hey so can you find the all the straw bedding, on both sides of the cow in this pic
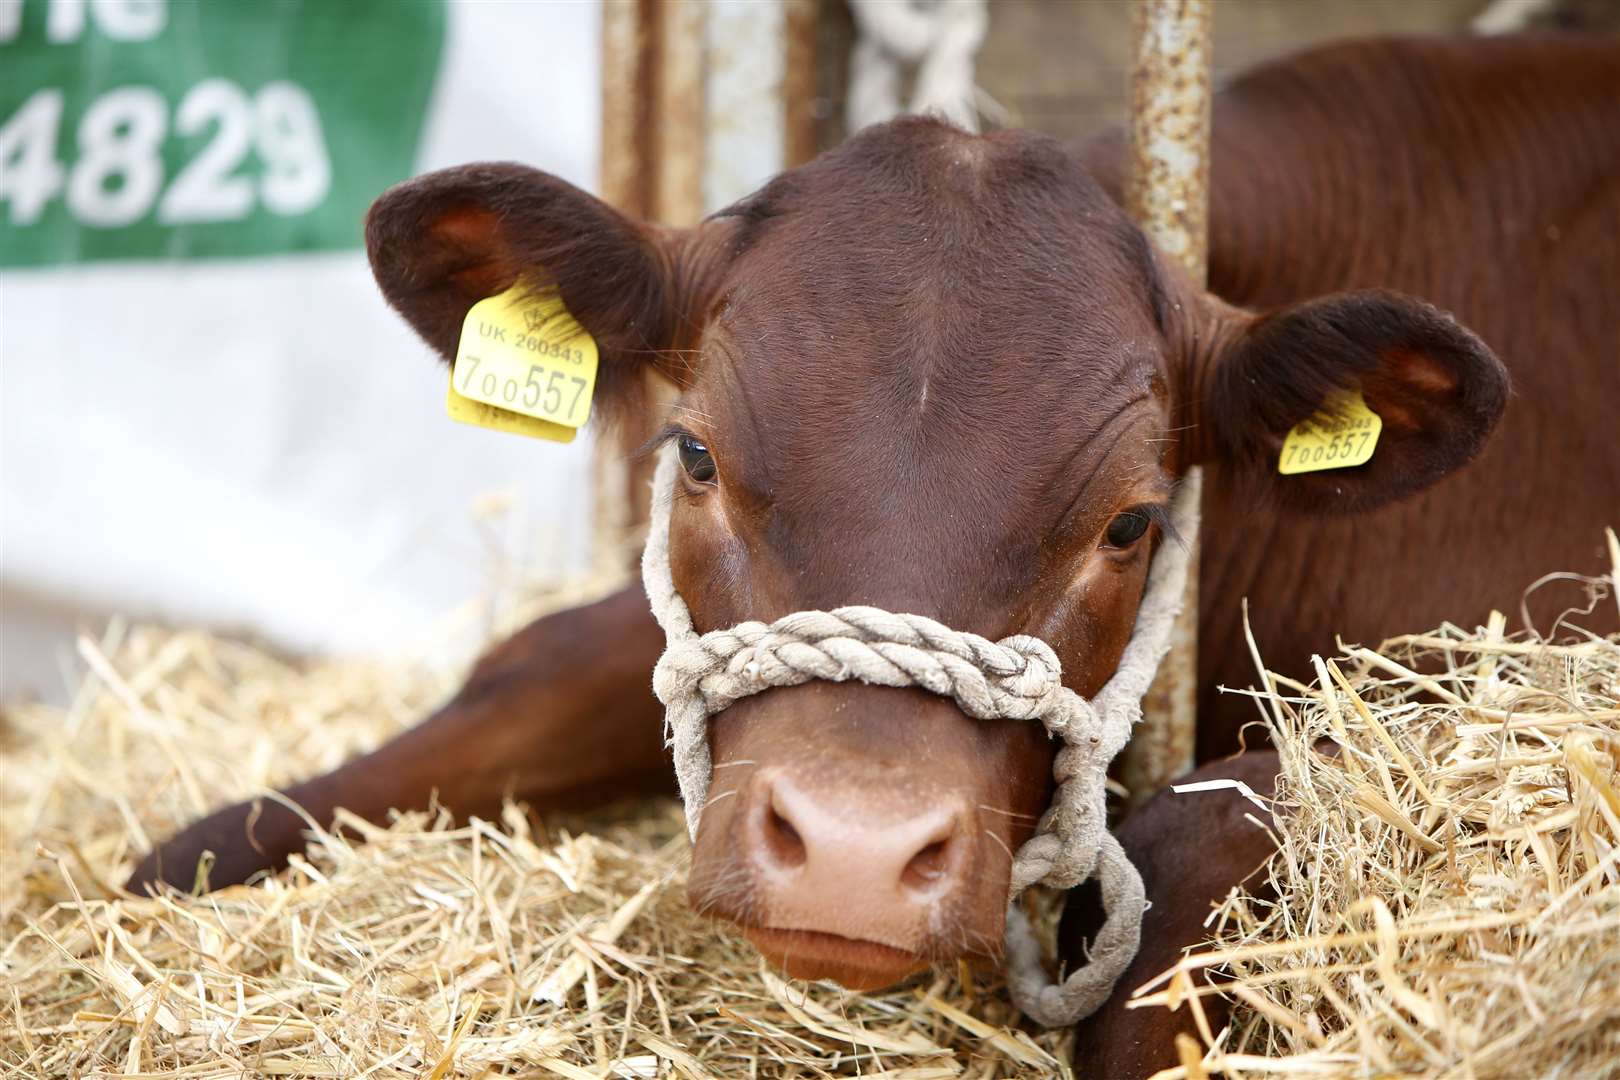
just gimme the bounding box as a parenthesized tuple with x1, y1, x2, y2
(0, 537, 1620, 1080)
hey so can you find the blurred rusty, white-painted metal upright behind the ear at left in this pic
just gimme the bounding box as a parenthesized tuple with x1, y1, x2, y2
(591, 0, 816, 573)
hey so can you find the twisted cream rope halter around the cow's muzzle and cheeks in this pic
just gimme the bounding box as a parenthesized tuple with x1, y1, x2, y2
(642, 445, 1199, 1027)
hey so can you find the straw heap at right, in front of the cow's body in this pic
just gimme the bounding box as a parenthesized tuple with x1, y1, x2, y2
(1137, 531, 1620, 1080)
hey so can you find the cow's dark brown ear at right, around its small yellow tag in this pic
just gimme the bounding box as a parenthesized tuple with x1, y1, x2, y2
(1192, 290, 1508, 513)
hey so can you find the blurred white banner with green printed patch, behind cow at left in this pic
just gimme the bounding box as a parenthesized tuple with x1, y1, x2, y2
(0, 0, 599, 695)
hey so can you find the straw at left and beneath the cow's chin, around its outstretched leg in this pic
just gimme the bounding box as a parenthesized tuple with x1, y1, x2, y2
(0, 589, 1072, 1080)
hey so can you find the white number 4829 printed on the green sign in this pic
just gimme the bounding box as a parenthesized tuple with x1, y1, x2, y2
(0, 79, 332, 228)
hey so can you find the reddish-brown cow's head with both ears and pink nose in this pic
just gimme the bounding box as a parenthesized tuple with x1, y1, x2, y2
(368, 120, 1507, 986)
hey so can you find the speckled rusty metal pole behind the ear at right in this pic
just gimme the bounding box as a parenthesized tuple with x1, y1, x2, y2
(1121, 0, 1215, 805)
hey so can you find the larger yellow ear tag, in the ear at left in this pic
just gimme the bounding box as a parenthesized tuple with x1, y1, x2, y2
(444, 282, 596, 442)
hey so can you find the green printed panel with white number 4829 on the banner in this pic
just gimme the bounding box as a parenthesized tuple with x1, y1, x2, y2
(0, 0, 446, 267)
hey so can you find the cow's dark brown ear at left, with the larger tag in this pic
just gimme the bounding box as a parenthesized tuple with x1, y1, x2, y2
(366, 162, 690, 411)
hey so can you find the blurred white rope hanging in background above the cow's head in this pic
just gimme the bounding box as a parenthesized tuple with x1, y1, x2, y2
(846, 0, 990, 133)
